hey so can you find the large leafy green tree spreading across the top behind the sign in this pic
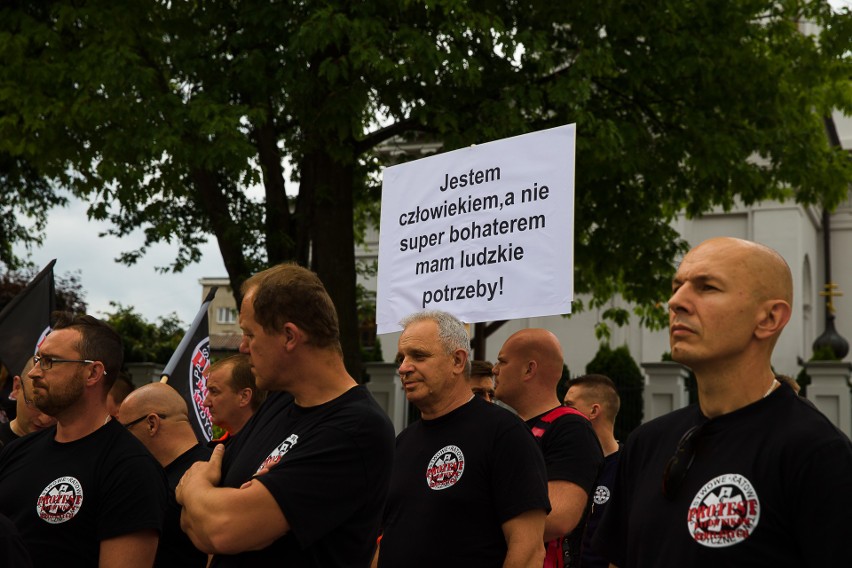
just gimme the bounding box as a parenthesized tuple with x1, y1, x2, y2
(0, 0, 852, 376)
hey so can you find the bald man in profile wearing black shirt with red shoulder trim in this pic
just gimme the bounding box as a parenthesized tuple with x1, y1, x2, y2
(494, 329, 603, 567)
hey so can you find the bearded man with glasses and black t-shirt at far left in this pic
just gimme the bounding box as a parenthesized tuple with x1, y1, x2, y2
(0, 314, 166, 568)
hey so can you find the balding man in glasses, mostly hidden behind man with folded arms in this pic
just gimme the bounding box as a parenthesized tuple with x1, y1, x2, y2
(119, 383, 211, 568)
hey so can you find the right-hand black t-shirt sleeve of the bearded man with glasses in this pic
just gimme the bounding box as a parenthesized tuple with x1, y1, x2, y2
(96, 454, 167, 540)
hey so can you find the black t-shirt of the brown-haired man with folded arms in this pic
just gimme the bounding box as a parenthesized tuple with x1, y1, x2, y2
(213, 386, 394, 568)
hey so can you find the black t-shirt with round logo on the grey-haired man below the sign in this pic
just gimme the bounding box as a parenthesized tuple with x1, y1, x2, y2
(379, 397, 550, 568)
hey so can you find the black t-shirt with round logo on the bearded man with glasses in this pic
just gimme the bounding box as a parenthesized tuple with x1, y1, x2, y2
(0, 420, 166, 567)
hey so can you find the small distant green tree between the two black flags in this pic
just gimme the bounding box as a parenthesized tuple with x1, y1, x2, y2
(105, 302, 186, 365)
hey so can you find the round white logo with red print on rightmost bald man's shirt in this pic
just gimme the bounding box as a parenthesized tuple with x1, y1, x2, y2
(686, 473, 760, 548)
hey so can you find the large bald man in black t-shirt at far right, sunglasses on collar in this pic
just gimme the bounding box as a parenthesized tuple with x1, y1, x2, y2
(593, 238, 852, 568)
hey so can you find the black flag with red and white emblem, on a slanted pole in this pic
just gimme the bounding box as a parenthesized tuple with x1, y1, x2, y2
(161, 286, 218, 443)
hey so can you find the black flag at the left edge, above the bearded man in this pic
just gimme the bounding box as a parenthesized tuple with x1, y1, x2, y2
(0, 259, 56, 377)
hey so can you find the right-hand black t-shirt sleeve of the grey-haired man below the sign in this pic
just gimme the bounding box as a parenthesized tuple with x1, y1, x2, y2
(490, 420, 550, 524)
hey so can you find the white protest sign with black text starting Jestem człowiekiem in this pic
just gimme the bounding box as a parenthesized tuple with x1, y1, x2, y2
(376, 124, 576, 333)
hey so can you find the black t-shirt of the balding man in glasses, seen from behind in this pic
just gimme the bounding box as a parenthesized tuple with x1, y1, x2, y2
(154, 444, 211, 568)
